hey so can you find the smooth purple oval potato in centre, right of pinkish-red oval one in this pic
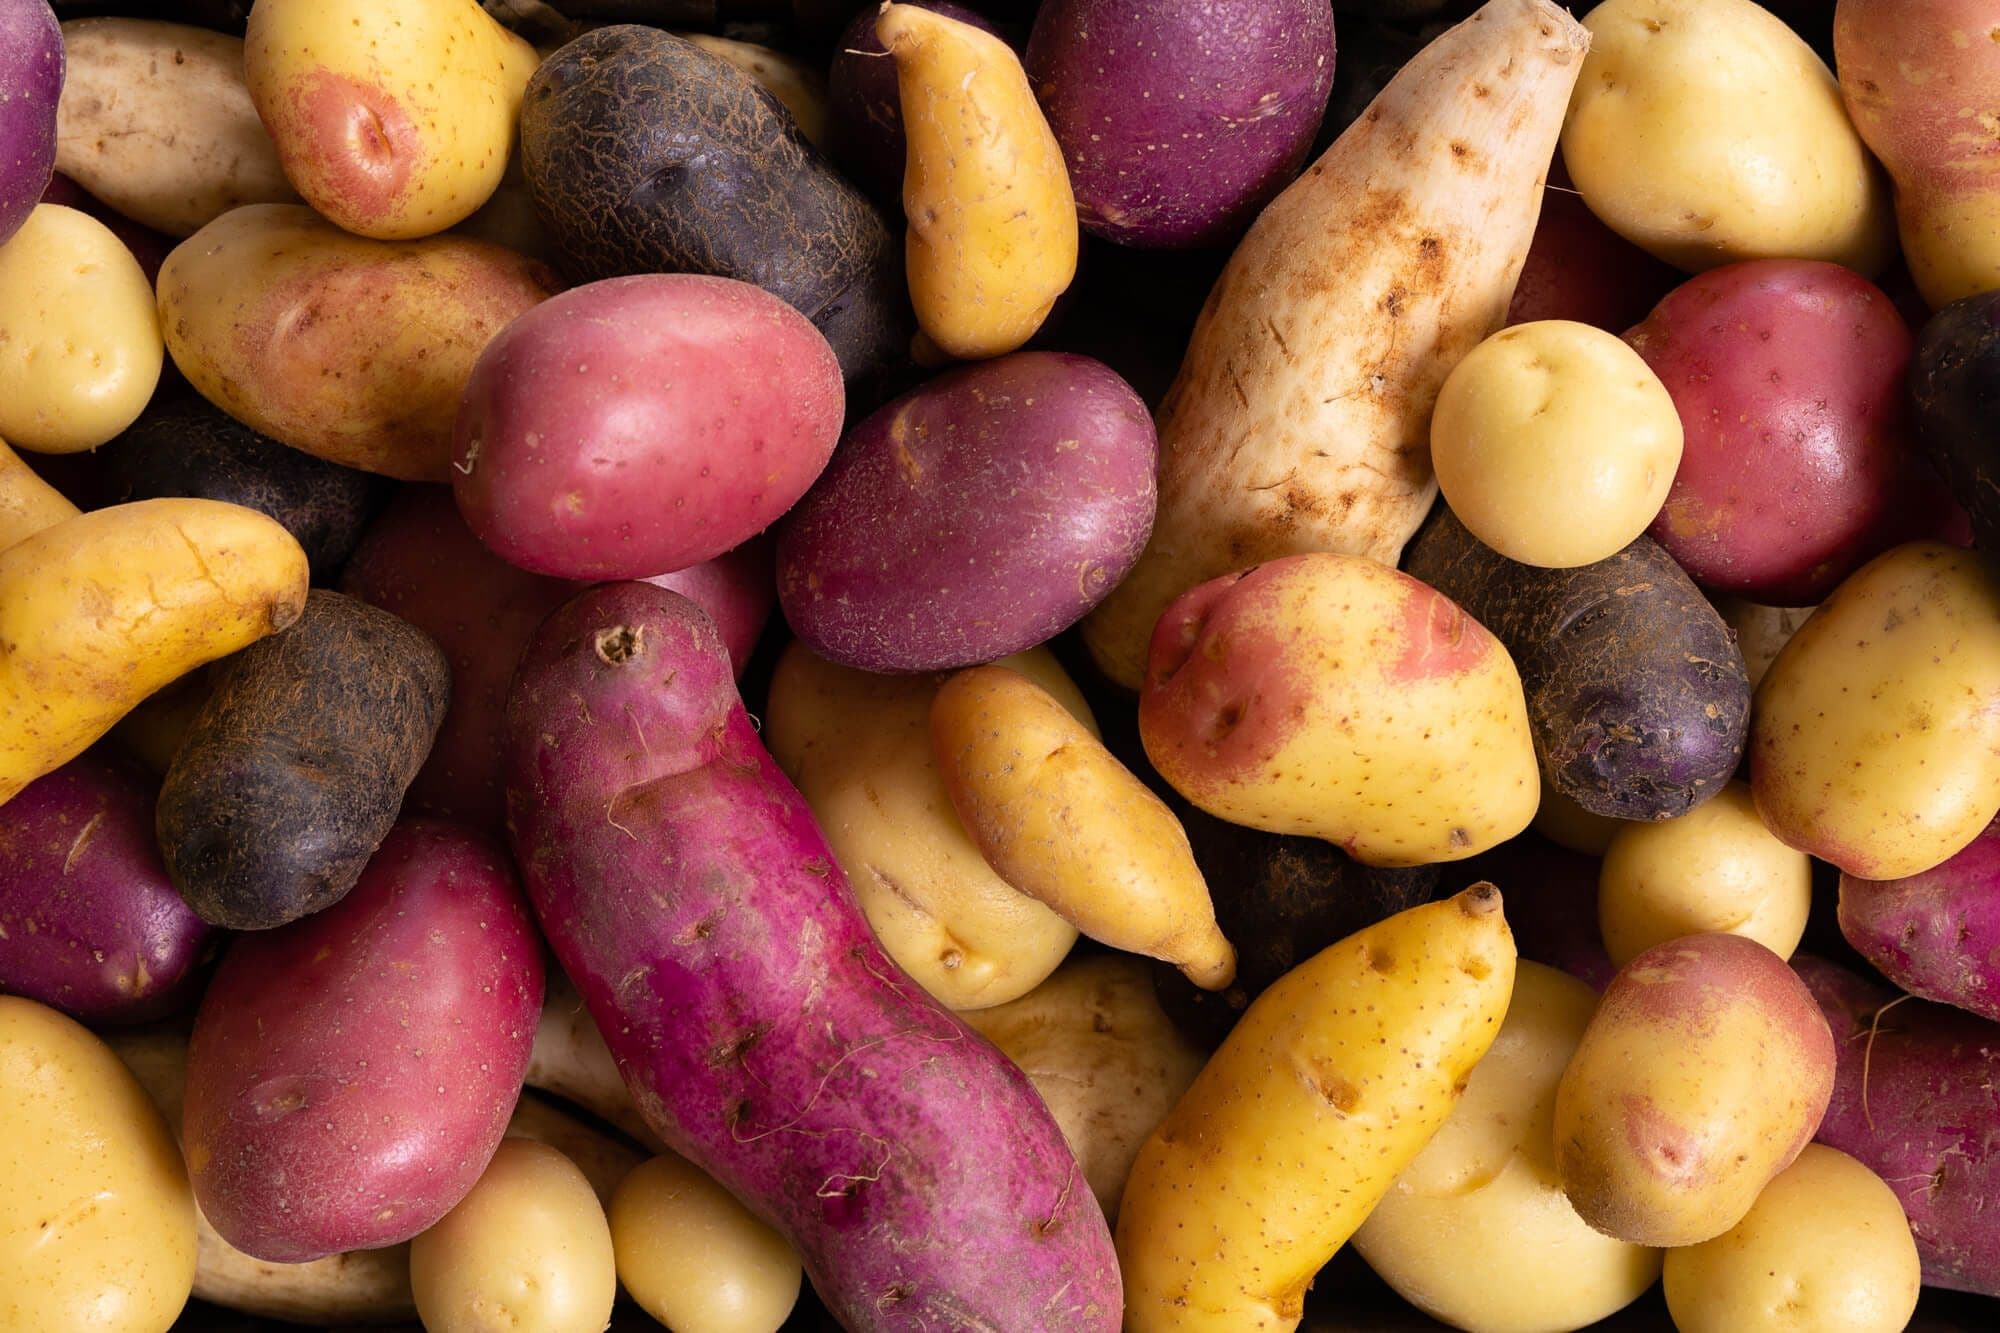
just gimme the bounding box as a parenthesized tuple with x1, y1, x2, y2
(778, 352, 1158, 671)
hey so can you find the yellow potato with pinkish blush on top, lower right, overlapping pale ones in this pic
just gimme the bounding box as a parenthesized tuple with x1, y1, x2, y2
(1556, 935, 1834, 1245)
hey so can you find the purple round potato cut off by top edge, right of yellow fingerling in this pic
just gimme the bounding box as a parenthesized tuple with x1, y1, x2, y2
(1026, 0, 1334, 248)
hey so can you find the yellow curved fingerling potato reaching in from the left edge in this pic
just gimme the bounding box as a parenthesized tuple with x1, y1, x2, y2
(0, 500, 308, 803)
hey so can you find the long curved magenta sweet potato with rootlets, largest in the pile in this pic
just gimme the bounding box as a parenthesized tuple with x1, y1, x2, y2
(508, 582, 1122, 1333)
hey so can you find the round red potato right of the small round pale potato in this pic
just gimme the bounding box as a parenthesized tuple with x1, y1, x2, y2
(1626, 260, 1920, 606)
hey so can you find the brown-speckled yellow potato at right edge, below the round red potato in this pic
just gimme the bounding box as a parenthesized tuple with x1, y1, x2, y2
(1750, 542, 2000, 879)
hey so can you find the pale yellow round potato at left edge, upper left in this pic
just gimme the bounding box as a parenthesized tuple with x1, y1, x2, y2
(0, 204, 162, 454)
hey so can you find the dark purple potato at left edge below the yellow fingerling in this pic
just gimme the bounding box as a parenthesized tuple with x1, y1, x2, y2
(0, 755, 214, 1023)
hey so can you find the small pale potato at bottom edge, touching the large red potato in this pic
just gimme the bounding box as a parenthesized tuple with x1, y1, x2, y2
(410, 1137, 618, 1333)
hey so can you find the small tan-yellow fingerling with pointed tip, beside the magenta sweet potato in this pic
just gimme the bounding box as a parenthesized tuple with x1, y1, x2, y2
(930, 667, 1236, 991)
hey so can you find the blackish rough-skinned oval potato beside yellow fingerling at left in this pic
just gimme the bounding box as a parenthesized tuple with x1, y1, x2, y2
(158, 588, 450, 931)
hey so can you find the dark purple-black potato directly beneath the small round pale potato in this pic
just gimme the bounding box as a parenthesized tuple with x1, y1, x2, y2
(1404, 504, 1750, 819)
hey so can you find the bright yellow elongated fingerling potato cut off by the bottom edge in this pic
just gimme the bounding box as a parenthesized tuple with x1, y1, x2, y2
(1118, 885, 1514, 1333)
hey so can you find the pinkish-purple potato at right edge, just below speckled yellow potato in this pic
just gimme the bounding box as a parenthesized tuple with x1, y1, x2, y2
(1840, 821, 2000, 1019)
